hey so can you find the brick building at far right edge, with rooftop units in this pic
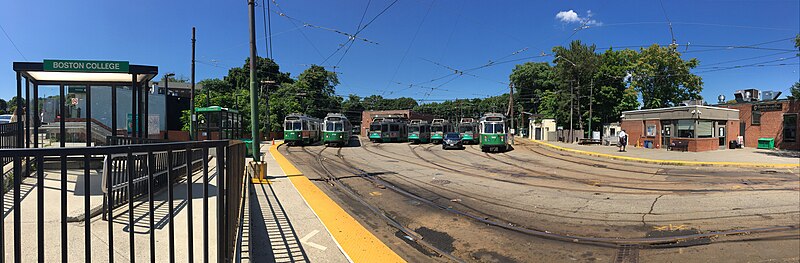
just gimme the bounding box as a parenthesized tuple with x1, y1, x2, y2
(717, 99, 800, 150)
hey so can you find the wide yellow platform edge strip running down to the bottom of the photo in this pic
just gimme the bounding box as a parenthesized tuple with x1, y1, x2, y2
(269, 145, 406, 263)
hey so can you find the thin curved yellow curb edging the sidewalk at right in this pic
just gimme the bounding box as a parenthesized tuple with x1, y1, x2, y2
(531, 140, 800, 168)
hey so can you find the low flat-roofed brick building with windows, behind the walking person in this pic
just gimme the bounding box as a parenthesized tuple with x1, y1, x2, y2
(620, 105, 739, 152)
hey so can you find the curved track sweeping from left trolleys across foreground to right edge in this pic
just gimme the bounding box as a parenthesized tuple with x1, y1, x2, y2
(306, 143, 798, 251)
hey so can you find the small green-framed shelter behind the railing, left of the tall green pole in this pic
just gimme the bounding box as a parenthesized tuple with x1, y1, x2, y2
(194, 106, 242, 140)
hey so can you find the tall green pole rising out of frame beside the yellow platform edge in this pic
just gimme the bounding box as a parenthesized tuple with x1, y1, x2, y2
(247, 0, 261, 162)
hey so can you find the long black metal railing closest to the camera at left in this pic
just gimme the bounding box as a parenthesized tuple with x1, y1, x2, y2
(0, 140, 247, 263)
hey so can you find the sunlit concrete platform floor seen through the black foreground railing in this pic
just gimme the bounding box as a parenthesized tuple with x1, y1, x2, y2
(3, 159, 222, 262)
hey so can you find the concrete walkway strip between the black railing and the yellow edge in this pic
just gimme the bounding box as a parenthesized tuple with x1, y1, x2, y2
(242, 143, 349, 262)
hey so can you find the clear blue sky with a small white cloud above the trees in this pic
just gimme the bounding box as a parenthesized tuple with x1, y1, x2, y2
(0, 0, 800, 102)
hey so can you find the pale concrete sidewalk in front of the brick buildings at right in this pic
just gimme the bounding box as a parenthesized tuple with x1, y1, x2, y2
(517, 138, 800, 167)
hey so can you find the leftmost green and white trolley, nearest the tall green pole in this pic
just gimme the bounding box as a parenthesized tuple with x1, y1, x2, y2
(283, 113, 322, 146)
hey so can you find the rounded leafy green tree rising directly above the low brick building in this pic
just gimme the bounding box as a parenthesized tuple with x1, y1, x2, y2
(631, 44, 703, 109)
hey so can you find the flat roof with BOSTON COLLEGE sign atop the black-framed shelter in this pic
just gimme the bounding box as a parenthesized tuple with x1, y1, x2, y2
(13, 60, 158, 84)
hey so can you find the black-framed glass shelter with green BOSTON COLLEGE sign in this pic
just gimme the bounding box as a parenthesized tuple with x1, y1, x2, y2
(13, 60, 158, 151)
